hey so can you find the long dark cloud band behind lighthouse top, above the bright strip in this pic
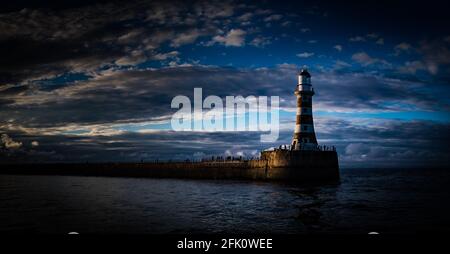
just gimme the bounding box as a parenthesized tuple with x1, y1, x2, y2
(0, 66, 437, 131)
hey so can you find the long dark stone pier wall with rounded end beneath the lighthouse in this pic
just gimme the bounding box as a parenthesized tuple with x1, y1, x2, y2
(0, 150, 339, 181)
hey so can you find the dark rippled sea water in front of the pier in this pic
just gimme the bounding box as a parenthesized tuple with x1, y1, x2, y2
(0, 169, 450, 234)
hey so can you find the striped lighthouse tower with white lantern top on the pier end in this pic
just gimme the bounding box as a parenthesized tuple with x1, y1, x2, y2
(292, 69, 317, 150)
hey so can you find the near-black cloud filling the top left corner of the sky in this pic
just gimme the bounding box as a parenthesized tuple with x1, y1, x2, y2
(0, 4, 150, 84)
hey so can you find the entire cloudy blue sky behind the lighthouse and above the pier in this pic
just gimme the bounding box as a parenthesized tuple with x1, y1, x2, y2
(0, 0, 450, 168)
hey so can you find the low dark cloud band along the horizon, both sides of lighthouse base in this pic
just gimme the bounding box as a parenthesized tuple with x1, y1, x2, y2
(0, 118, 450, 167)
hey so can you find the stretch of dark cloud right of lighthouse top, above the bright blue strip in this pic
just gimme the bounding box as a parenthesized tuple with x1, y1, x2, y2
(313, 70, 440, 112)
